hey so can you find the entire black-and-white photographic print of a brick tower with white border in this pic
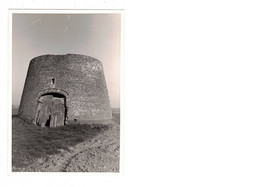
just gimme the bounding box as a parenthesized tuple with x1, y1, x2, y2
(9, 10, 122, 173)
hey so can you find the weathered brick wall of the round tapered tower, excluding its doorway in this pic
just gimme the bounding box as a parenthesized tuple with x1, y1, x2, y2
(18, 54, 112, 123)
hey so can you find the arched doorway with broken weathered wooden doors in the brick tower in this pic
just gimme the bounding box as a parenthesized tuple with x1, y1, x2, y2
(34, 92, 67, 127)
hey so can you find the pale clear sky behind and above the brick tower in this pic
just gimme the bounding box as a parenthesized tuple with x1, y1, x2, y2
(12, 13, 121, 108)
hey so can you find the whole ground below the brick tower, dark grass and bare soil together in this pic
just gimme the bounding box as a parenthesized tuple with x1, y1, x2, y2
(12, 108, 120, 172)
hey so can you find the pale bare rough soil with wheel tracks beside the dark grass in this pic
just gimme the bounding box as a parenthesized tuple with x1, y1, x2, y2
(13, 113, 120, 172)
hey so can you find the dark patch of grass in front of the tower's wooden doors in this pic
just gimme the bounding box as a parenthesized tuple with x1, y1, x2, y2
(12, 116, 109, 167)
